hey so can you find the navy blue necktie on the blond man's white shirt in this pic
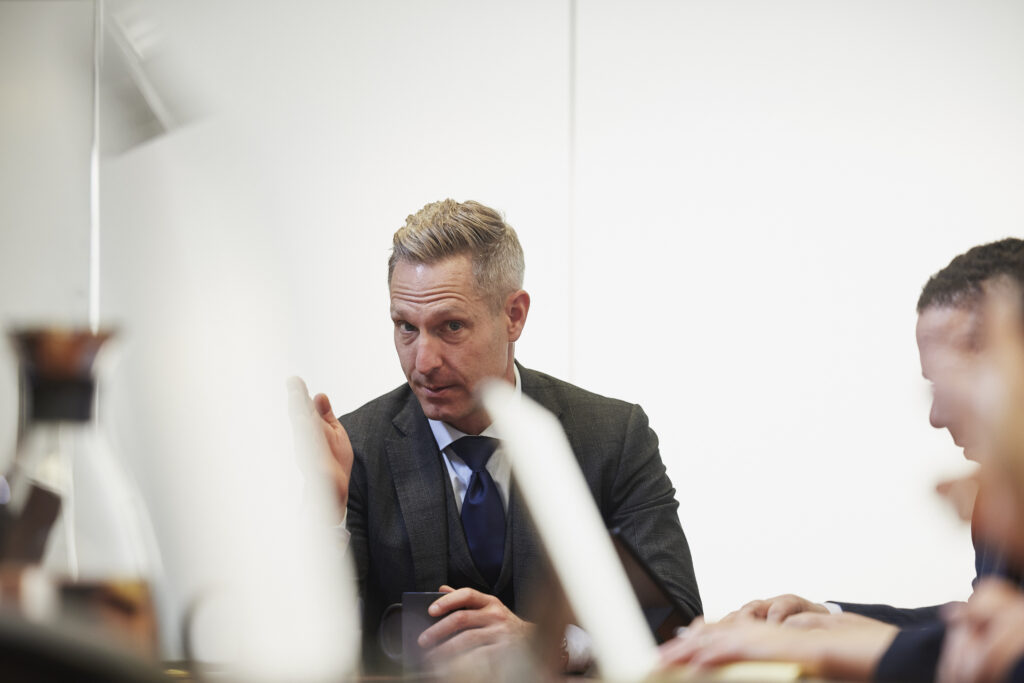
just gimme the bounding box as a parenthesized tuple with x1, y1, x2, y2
(452, 436, 505, 588)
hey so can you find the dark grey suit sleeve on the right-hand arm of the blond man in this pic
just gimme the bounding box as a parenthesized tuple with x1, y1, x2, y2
(605, 405, 703, 618)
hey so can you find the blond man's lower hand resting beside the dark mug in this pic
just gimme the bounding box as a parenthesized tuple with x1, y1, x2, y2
(419, 586, 534, 661)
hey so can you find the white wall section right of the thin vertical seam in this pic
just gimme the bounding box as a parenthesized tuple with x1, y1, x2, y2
(571, 0, 1024, 614)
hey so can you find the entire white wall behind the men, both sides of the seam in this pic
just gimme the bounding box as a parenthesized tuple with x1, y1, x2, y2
(0, 0, 1024, 647)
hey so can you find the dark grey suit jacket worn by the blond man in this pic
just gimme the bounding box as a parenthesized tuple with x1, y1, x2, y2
(340, 366, 702, 658)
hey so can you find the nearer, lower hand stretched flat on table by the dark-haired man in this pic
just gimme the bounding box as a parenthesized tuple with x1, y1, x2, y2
(660, 614, 897, 680)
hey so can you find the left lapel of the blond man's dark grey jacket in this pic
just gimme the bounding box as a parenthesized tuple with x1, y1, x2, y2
(385, 395, 451, 591)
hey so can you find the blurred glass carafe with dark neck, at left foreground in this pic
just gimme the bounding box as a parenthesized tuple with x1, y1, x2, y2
(0, 329, 161, 658)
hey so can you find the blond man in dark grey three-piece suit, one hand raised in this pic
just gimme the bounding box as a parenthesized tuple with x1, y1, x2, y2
(314, 200, 701, 670)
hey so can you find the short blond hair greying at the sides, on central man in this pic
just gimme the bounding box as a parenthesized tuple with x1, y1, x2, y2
(387, 200, 526, 308)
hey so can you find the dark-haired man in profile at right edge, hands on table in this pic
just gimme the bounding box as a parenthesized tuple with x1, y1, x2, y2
(665, 238, 1024, 681)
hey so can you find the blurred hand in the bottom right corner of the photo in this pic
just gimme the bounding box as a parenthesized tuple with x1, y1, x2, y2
(936, 579, 1024, 683)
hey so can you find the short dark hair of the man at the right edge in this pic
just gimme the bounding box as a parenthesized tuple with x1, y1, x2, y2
(918, 238, 1024, 313)
